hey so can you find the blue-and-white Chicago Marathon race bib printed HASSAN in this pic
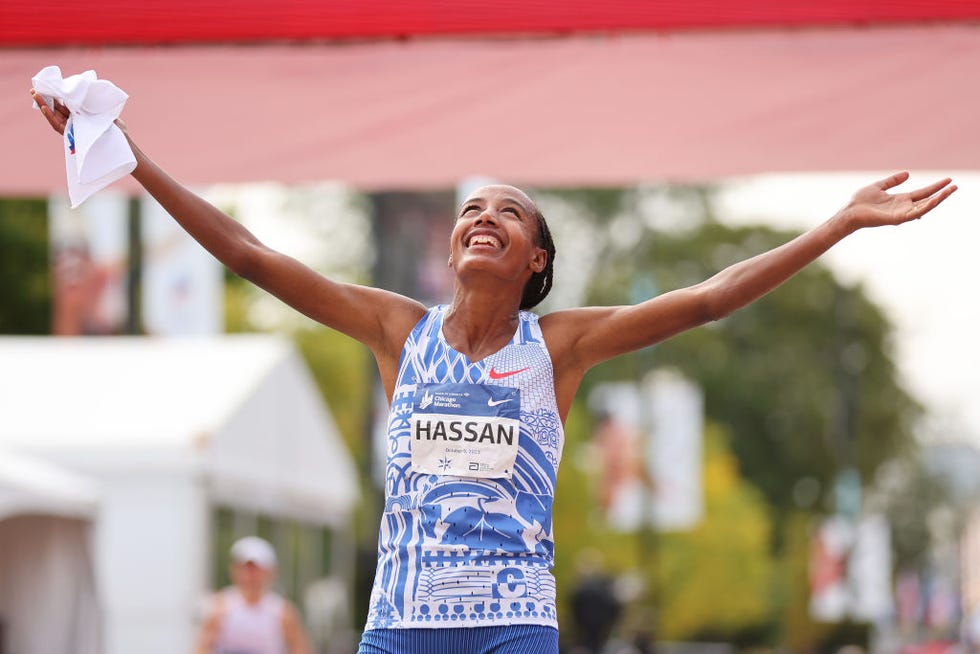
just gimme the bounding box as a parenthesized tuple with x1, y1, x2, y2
(411, 384, 521, 479)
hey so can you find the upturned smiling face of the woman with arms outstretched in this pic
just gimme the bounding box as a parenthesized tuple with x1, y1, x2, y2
(450, 185, 547, 288)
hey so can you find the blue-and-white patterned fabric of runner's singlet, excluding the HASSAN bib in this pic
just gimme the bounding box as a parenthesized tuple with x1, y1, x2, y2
(366, 306, 564, 629)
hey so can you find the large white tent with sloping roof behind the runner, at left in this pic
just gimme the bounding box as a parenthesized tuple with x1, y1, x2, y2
(0, 336, 356, 654)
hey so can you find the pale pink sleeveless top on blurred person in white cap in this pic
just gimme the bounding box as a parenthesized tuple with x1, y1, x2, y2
(214, 588, 286, 654)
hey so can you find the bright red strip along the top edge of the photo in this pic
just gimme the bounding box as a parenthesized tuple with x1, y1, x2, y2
(0, 0, 980, 46)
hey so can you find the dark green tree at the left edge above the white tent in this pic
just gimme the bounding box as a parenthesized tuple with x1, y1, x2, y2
(0, 198, 51, 334)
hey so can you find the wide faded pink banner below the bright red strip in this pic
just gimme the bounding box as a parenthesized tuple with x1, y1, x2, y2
(0, 24, 980, 195)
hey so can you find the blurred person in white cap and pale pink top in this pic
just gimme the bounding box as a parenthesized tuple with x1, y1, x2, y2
(194, 536, 312, 654)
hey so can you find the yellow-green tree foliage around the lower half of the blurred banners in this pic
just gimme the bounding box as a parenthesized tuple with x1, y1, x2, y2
(555, 418, 775, 641)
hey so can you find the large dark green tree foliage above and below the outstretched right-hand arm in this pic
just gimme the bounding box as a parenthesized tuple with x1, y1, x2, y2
(536, 188, 920, 513)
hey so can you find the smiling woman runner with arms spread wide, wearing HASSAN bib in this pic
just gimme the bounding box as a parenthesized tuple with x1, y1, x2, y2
(30, 88, 956, 654)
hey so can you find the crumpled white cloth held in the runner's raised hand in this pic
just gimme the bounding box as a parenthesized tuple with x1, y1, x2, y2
(31, 66, 136, 209)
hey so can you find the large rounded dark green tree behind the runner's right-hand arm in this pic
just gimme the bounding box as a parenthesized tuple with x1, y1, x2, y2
(648, 223, 918, 512)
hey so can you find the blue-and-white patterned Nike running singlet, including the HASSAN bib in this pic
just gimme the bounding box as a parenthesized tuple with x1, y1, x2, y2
(366, 305, 564, 629)
